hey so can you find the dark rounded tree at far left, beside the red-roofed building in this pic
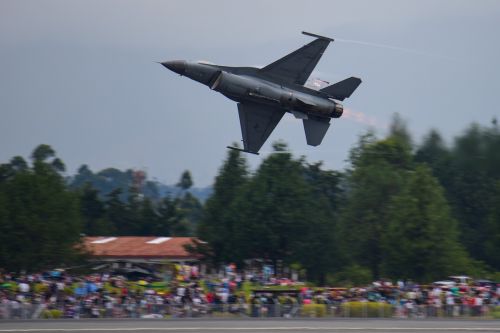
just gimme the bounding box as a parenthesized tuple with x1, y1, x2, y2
(0, 145, 82, 271)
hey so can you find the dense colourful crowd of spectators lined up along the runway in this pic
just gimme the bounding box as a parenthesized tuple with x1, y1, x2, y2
(0, 271, 500, 319)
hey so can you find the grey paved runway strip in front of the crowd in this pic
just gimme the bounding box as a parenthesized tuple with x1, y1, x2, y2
(0, 319, 500, 333)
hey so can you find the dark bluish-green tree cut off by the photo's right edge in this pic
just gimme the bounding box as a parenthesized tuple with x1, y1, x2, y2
(447, 124, 500, 269)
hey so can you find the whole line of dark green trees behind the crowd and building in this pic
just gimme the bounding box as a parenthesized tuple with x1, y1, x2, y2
(0, 117, 500, 284)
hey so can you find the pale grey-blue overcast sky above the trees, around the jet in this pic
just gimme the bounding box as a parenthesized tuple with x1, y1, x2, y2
(0, 0, 500, 186)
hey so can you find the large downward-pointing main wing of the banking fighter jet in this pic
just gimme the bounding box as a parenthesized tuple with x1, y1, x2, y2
(238, 103, 285, 154)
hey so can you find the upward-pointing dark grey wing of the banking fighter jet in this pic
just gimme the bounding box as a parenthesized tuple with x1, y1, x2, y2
(260, 32, 333, 85)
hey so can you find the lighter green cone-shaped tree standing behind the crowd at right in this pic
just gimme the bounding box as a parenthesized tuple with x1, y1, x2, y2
(381, 166, 468, 282)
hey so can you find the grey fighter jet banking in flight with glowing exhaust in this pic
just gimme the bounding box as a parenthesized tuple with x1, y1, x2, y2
(161, 31, 361, 154)
